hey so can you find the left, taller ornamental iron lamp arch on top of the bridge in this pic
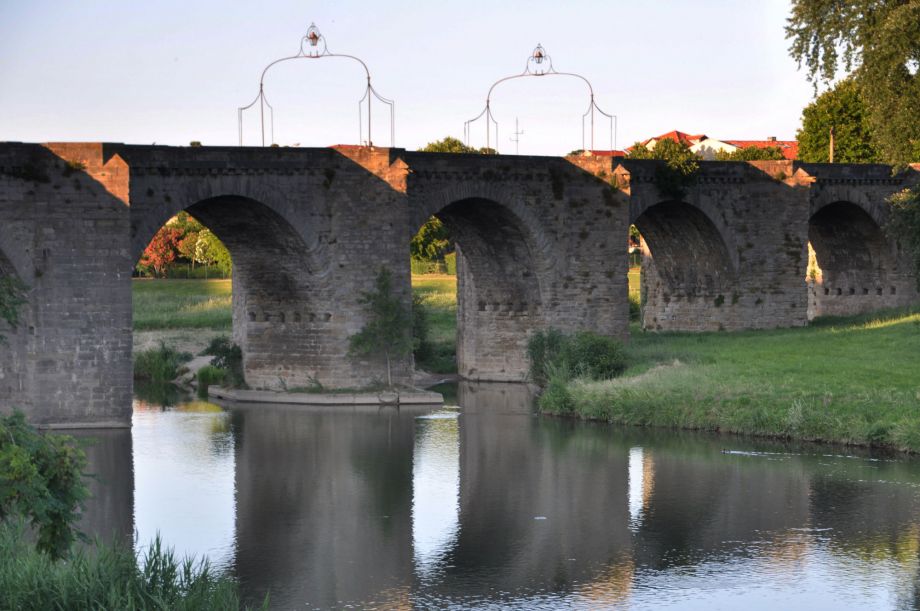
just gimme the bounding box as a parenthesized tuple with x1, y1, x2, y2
(237, 23, 396, 146)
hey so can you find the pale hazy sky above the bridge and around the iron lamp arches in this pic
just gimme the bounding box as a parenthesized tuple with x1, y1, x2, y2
(0, 0, 812, 155)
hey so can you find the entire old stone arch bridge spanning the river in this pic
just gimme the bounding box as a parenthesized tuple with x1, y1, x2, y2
(0, 143, 918, 426)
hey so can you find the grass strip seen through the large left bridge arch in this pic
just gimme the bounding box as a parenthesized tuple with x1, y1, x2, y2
(132, 279, 232, 331)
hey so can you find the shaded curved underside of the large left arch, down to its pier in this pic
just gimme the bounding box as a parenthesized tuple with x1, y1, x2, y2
(133, 195, 341, 390)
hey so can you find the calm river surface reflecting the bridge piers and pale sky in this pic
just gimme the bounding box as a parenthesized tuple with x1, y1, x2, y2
(77, 383, 920, 611)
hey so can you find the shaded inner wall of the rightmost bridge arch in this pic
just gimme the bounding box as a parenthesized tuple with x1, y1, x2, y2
(806, 201, 903, 320)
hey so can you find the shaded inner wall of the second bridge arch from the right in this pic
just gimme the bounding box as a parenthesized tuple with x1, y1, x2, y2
(634, 201, 737, 330)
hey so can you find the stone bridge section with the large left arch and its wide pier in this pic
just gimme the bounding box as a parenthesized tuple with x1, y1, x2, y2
(126, 149, 409, 390)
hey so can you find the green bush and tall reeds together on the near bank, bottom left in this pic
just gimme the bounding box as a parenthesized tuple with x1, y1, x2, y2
(0, 412, 268, 610)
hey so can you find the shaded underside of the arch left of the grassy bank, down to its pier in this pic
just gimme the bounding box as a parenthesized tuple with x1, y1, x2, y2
(424, 197, 543, 381)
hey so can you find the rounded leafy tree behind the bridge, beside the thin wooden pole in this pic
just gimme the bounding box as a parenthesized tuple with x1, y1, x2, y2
(796, 79, 880, 163)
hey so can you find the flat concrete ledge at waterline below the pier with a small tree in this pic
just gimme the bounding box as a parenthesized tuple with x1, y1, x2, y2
(208, 386, 444, 406)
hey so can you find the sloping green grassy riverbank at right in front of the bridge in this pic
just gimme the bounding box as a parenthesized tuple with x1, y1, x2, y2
(541, 310, 920, 452)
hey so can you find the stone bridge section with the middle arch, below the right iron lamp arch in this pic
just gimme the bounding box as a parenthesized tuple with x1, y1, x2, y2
(406, 153, 628, 381)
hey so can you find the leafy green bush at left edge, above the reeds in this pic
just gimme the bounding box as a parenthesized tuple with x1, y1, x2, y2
(0, 411, 89, 560)
